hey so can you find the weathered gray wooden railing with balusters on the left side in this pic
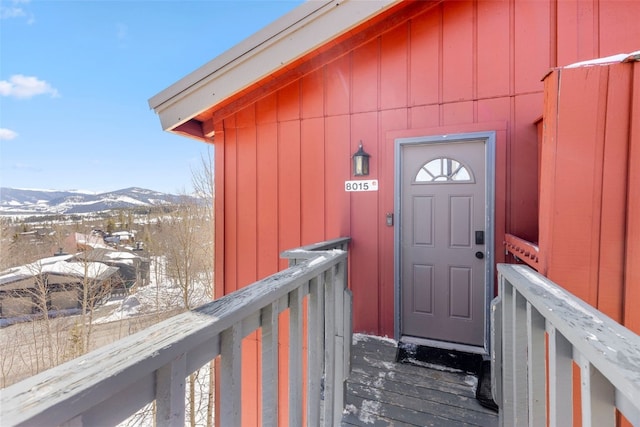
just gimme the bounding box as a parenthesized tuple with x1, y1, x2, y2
(0, 239, 351, 426)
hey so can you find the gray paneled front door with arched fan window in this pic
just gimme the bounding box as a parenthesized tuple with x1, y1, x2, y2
(399, 139, 489, 346)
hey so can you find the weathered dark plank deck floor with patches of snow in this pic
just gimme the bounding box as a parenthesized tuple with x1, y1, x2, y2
(342, 335, 498, 427)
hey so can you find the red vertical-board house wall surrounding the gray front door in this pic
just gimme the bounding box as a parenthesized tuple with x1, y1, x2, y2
(214, 0, 640, 425)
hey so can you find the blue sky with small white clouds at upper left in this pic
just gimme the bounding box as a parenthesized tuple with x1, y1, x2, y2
(0, 0, 301, 193)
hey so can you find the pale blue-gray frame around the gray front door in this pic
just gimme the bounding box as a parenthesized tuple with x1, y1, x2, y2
(394, 131, 496, 354)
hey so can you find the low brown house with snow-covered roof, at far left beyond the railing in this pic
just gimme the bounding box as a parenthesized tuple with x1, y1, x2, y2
(0, 255, 120, 319)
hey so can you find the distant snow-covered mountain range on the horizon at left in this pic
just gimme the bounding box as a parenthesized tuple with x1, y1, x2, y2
(0, 187, 189, 215)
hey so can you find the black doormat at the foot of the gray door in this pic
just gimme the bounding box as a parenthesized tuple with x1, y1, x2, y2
(396, 341, 498, 411)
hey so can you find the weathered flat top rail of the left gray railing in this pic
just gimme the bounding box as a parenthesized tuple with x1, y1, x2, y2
(0, 250, 347, 425)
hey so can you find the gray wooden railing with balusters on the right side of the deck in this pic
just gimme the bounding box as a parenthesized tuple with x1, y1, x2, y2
(491, 264, 640, 427)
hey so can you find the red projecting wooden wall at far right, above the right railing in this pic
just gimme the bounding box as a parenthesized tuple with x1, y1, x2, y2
(540, 62, 640, 333)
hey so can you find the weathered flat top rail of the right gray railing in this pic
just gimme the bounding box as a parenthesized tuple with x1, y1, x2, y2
(498, 264, 640, 402)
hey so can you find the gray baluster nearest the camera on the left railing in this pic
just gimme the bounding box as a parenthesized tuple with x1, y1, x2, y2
(156, 354, 187, 427)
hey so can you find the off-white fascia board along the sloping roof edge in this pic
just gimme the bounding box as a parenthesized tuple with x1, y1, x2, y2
(149, 0, 400, 130)
